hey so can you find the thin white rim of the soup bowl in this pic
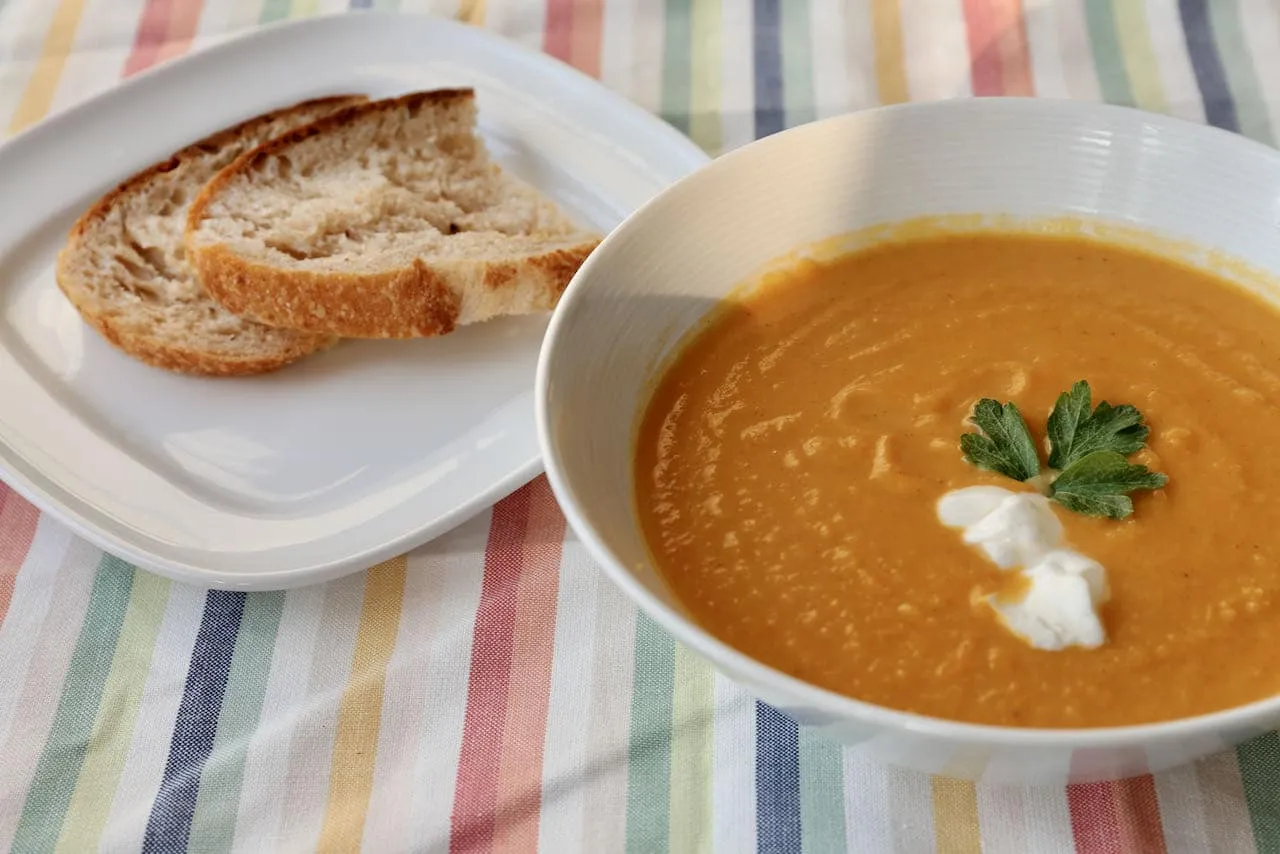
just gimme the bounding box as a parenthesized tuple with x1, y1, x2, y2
(534, 96, 1280, 749)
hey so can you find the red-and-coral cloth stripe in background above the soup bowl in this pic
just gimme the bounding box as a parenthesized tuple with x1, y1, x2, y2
(964, 0, 1034, 95)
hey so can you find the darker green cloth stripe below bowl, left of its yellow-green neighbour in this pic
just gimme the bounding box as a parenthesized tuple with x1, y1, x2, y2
(627, 612, 676, 854)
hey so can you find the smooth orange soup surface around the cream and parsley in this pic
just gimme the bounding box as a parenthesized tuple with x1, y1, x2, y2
(636, 226, 1280, 727)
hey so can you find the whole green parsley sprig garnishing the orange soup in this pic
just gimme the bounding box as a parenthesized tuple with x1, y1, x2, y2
(960, 380, 1169, 519)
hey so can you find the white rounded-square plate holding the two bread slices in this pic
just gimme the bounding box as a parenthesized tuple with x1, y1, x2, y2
(0, 13, 707, 589)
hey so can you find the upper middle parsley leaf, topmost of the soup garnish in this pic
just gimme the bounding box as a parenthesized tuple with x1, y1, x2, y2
(1048, 380, 1149, 471)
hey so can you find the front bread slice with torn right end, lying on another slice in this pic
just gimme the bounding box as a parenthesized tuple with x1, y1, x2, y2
(187, 90, 599, 338)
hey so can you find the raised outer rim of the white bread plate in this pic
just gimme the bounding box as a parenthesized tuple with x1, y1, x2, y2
(0, 10, 712, 590)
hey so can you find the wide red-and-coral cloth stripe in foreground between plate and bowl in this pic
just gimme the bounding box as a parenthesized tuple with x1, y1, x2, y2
(449, 478, 564, 854)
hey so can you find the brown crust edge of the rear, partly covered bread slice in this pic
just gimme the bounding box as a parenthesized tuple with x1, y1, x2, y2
(54, 95, 366, 376)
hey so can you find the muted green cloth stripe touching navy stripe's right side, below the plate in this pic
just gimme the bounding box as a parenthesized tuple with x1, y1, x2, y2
(191, 592, 285, 851)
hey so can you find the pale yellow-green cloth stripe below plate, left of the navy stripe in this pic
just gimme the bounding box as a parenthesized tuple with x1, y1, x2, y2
(58, 572, 170, 854)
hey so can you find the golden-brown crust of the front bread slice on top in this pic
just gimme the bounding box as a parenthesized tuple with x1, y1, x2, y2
(187, 88, 599, 338)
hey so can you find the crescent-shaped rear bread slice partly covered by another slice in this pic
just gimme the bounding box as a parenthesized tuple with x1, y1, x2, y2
(56, 96, 365, 376)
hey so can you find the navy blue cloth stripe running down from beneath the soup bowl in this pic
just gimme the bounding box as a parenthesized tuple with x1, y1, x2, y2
(755, 702, 801, 854)
